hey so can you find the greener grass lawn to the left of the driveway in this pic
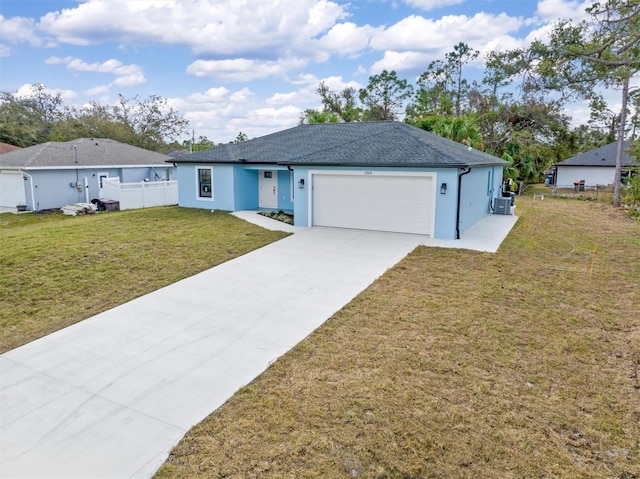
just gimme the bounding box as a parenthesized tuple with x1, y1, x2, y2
(0, 207, 287, 352)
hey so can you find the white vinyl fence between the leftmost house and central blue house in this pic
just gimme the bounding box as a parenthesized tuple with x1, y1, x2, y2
(100, 178, 178, 210)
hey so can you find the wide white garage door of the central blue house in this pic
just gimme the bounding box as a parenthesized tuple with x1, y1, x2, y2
(313, 172, 435, 236)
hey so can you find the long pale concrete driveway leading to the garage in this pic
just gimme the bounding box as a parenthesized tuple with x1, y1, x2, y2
(0, 216, 515, 478)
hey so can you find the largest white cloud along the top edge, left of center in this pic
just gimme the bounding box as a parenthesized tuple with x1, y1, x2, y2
(40, 0, 347, 57)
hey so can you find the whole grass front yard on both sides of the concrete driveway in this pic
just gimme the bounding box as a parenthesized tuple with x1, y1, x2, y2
(0, 197, 640, 478)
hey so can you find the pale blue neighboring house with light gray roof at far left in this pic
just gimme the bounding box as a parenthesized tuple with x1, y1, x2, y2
(0, 138, 175, 211)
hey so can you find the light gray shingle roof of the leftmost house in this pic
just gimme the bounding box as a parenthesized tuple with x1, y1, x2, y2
(0, 138, 170, 169)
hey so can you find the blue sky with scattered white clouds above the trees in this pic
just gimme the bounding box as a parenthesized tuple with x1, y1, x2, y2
(0, 0, 615, 143)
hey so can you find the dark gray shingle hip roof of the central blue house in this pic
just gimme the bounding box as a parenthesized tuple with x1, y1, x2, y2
(171, 121, 507, 168)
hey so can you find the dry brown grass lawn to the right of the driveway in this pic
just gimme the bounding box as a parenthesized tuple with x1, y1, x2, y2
(157, 198, 640, 478)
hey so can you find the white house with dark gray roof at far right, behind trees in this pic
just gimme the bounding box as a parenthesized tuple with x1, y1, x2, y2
(553, 141, 639, 187)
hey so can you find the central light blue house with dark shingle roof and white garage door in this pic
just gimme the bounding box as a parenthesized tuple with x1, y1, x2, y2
(171, 121, 506, 239)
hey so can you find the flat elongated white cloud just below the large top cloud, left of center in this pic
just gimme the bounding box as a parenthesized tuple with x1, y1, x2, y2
(187, 58, 307, 82)
